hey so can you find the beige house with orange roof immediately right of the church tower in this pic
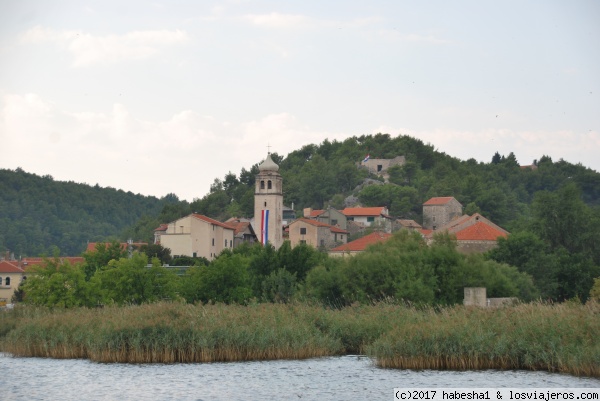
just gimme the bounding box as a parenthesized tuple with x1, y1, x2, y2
(288, 217, 348, 249)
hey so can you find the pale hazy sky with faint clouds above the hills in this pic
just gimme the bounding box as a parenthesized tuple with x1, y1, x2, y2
(0, 0, 600, 201)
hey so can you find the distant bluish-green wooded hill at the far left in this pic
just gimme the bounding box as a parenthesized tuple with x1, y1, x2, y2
(0, 168, 179, 257)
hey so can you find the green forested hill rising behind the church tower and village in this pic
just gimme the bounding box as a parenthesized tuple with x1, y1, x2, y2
(178, 134, 600, 229)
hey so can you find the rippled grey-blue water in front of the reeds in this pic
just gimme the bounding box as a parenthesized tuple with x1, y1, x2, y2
(0, 354, 600, 401)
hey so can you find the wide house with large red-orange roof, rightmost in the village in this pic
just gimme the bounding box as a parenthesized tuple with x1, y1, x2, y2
(425, 213, 509, 253)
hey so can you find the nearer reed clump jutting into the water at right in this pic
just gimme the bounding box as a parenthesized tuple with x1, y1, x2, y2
(367, 303, 600, 377)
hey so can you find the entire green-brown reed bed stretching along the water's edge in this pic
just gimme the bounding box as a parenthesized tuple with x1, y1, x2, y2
(0, 302, 600, 377)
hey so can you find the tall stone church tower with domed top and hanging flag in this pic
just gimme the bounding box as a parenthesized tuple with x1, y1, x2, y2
(254, 153, 283, 249)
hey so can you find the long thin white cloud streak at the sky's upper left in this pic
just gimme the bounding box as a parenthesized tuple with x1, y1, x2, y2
(21, 26, 189, 67)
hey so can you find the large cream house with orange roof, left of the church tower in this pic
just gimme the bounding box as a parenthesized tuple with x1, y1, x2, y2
(160, 213, 235, 260)
